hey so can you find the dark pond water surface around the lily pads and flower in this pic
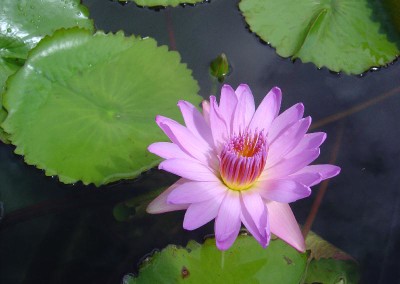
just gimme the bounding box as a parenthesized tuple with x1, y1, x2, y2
(0, 0, 400, 283)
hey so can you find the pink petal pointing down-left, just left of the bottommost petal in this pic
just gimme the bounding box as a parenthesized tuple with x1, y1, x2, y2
(183, 193, 226, 230)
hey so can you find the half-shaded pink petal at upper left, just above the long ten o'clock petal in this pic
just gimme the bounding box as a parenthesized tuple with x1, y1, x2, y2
(178, 101, 214, 148)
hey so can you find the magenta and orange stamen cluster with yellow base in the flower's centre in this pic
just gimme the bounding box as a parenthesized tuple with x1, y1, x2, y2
(220, 131, 267, 190)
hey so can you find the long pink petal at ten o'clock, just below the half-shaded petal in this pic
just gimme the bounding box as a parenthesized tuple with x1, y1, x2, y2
(156, 116, 212, 165)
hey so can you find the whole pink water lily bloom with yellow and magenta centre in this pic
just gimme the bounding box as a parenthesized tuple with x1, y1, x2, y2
(147, 84, 340, 251)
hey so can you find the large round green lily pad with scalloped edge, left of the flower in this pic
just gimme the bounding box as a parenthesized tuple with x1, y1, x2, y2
(2, 28, 200, 186)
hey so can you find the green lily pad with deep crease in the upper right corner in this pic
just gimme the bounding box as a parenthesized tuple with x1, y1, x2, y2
(239, 0, 400, 74)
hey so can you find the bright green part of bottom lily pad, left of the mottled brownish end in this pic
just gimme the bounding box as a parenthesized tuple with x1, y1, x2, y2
(124, 236, 307, 284)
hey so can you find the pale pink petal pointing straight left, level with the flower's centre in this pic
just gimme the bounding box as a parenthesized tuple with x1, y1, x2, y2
(158, 159, 219, 181)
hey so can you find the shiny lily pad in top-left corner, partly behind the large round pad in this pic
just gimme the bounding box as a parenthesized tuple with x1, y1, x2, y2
(0, 0, 94, 143)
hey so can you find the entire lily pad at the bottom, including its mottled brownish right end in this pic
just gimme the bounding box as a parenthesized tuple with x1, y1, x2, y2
(123, 232, 359, 284)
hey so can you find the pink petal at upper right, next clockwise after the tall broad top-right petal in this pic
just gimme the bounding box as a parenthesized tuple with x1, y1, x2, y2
(268, 103, 304, 143)
